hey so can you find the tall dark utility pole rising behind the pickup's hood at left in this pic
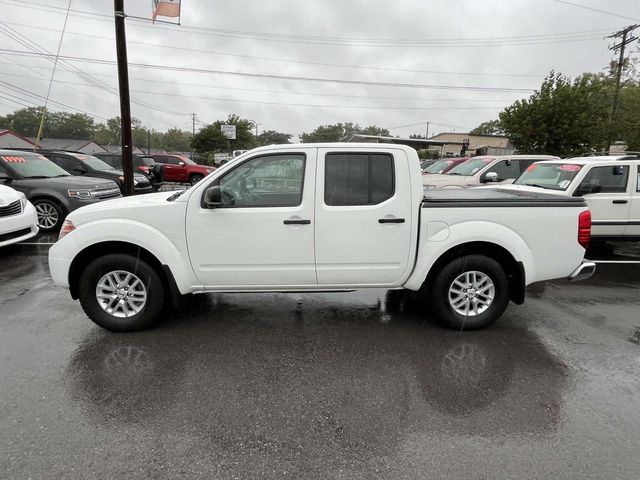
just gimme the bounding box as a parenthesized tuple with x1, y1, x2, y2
(113, 0, 133, 195)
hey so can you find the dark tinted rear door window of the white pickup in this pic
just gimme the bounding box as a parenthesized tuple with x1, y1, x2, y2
(324, 153, 395, 206)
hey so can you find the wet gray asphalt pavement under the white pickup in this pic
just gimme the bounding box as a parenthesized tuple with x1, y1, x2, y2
(0, 238, 640, 479)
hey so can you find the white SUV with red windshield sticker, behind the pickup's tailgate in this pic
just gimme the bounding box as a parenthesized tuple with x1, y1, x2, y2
(501, 155, 640, 241)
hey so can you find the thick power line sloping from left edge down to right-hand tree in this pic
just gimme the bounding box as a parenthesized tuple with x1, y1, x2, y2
(0, 48, 534, 93)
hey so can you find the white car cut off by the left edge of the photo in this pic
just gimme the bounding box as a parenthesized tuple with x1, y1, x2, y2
(0, 185, 38, 247)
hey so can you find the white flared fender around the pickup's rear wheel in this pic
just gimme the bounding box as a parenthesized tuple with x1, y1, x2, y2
(405, 220, 535, 290)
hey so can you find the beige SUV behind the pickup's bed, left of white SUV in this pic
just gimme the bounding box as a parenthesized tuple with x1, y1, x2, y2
(422, 155, 558, 191)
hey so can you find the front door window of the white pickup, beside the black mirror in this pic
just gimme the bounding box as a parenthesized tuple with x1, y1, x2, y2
(218, 153, 306, 207)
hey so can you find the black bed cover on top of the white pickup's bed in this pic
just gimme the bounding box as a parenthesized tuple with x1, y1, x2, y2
(422, 188, 587, 208)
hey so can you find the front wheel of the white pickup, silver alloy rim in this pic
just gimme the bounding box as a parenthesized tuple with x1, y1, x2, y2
(78, 253, 164, 332)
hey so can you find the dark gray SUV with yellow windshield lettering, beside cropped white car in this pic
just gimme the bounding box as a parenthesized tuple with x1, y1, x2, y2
(0, 150, 122, 231)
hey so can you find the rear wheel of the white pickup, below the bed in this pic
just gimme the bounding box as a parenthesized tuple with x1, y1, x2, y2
(430, 255, 509, 330)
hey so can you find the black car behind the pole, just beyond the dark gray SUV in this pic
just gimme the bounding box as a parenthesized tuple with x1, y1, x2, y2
(38, 150, 153, 195)
